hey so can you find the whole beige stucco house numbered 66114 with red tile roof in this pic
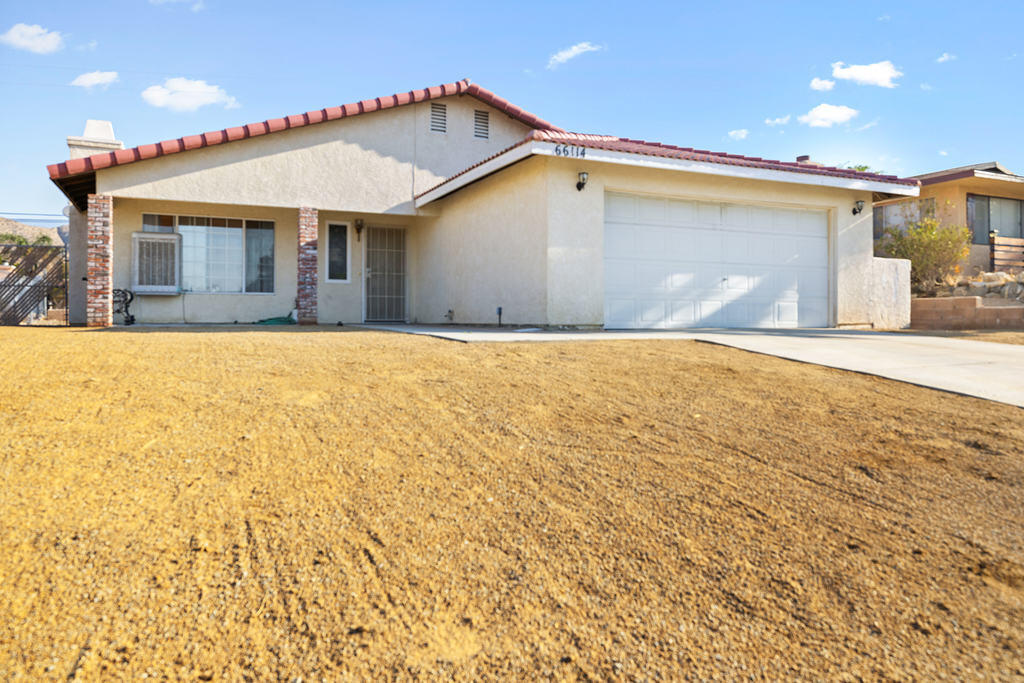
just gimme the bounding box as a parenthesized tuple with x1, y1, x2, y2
(49, 80, 919, 328)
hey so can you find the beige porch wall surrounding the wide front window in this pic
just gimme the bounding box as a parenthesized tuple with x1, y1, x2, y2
(114, 199, 299, 323)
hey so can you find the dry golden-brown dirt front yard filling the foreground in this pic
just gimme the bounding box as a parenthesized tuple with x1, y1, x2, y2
(0, 328, 1024, 680)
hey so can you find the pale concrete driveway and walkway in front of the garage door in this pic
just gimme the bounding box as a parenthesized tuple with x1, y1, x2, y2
(365, 325, 1024, 408)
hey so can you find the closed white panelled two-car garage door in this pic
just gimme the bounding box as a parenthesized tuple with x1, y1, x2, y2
(604, 193, 828, 329)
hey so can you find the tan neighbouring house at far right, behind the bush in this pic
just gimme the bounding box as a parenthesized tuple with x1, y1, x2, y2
(873, 162, 1024, 270)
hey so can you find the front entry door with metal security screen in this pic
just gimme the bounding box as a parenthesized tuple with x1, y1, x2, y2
(366, 227, 406, 323)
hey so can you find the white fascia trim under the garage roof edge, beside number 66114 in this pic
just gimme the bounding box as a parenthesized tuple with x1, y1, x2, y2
(416, 141, 921, 209)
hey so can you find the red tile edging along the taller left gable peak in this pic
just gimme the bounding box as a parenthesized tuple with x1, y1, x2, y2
(46, 79, 561, 180)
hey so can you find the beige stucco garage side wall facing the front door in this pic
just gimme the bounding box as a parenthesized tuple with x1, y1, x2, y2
(411, 159, 549, 325)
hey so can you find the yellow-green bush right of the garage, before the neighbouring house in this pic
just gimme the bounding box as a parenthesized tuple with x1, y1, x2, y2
(880, 216, 971, 294)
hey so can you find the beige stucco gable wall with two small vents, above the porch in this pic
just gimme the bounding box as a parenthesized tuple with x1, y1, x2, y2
(96, 95, 529, 214)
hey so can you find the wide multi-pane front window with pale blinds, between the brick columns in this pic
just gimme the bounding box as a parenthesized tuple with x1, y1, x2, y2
(142, 214, 273, 294)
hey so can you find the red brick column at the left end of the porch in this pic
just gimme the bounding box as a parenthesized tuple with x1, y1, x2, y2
(85, 195, 114, 328)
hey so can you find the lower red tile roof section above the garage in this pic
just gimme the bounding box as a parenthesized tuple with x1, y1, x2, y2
(416, 130, 921, 199)
